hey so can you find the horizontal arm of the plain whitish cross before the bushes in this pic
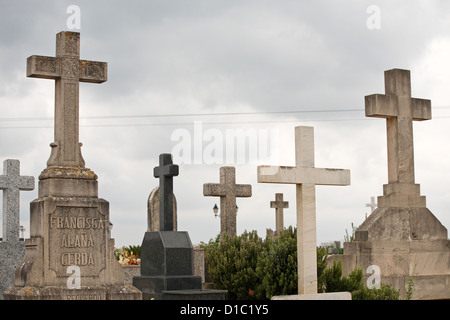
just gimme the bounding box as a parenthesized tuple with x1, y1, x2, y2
(257, 166, 350, 186)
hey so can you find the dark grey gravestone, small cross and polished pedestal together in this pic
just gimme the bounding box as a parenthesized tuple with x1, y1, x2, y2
(133, 154, 225, 300)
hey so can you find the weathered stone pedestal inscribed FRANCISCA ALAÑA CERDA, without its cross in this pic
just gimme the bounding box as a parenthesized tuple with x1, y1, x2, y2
(4, 168, 141, 300)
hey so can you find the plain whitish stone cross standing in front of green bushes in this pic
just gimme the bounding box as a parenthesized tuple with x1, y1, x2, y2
(257, 127, 350, 294)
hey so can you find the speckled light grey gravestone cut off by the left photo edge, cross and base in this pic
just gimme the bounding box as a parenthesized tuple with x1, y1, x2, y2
(0, 159, 34, 299)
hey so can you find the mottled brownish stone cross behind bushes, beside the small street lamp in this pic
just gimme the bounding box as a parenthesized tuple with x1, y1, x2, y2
(203, 167, 252, 237)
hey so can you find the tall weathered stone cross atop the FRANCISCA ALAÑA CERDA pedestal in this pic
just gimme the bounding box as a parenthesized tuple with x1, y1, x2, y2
(27, 31, 107, 167)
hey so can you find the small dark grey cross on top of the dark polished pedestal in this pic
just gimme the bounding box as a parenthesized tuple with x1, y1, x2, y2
(153, 153, 178, 231)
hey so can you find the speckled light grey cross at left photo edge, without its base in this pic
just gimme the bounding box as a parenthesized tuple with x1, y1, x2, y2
(0, 159, 34, 242)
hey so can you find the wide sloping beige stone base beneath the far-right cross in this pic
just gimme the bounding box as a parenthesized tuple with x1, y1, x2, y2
(327, 208, 450, 300)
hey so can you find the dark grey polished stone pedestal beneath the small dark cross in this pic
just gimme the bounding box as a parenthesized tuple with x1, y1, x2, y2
(133, 231, 226, 300)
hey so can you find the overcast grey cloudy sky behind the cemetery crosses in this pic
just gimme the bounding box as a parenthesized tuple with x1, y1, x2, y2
(0, 0, 450, 247)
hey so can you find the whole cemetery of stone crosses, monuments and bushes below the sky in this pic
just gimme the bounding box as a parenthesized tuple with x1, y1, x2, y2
(0, 31, 450, 300)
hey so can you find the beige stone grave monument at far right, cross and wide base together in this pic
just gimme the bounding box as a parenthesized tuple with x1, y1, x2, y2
(328, 69, 450, 299)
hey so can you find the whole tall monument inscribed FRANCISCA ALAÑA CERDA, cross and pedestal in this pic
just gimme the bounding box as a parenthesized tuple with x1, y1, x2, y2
(4, 32, 141, 300)
